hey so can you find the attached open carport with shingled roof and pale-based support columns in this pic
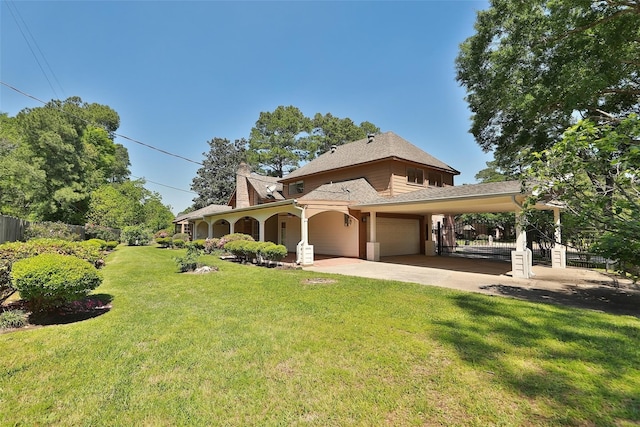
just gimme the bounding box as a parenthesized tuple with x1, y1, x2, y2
(352, 181, 566, 278)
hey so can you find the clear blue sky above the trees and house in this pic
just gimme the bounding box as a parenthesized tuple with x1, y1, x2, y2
(0, 0, 492, 213)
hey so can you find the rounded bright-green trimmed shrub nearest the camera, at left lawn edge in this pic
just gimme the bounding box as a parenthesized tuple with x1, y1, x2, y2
(11, 254, 102, 311)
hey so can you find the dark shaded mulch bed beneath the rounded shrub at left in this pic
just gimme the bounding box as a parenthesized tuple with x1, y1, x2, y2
(29, 294, 113, 326)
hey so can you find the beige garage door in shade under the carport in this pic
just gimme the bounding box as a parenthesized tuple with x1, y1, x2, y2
(376, 218, 420, 256)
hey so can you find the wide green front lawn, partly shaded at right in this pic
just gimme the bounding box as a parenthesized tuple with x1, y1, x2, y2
(0, 247, 640, 426)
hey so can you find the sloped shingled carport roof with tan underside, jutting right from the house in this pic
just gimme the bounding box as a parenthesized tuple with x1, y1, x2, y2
(353, 181, 527, 214)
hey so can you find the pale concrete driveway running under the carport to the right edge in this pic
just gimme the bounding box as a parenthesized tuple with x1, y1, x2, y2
(304, 255, 640, 315)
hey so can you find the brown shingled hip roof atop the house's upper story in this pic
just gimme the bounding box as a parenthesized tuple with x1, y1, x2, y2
(281, 132, 460, 181)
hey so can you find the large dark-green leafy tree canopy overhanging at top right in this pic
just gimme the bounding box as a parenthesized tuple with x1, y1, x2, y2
(456, 0, 640, 169)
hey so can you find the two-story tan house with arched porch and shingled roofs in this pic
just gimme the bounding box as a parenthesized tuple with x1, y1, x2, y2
(175, 132, 559, 275)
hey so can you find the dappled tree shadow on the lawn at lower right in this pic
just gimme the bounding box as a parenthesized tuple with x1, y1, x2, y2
(438, 294, 640, 426)
